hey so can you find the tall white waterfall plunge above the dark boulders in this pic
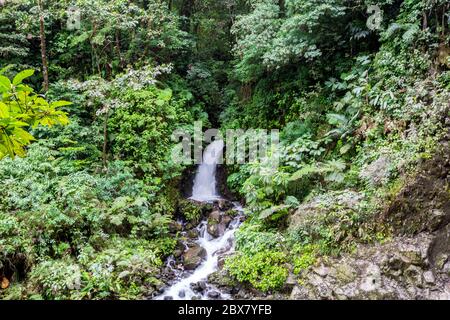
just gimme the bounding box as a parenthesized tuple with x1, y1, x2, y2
(191, 140, 224, 201)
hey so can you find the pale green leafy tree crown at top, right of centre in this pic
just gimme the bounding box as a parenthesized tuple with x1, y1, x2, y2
(233, 0, 346, 82)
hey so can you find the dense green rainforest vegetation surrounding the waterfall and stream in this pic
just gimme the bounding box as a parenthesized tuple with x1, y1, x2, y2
(0, 0, 450, 299)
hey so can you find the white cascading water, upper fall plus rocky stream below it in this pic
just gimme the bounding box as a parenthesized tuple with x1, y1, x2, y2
(157, 140, 242, 300)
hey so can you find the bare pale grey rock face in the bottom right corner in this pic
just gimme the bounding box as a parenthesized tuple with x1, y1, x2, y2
(291, 234, 450, 299)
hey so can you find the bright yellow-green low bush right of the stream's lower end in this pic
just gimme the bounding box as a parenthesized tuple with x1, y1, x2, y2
(225, 251, 288, 292)
